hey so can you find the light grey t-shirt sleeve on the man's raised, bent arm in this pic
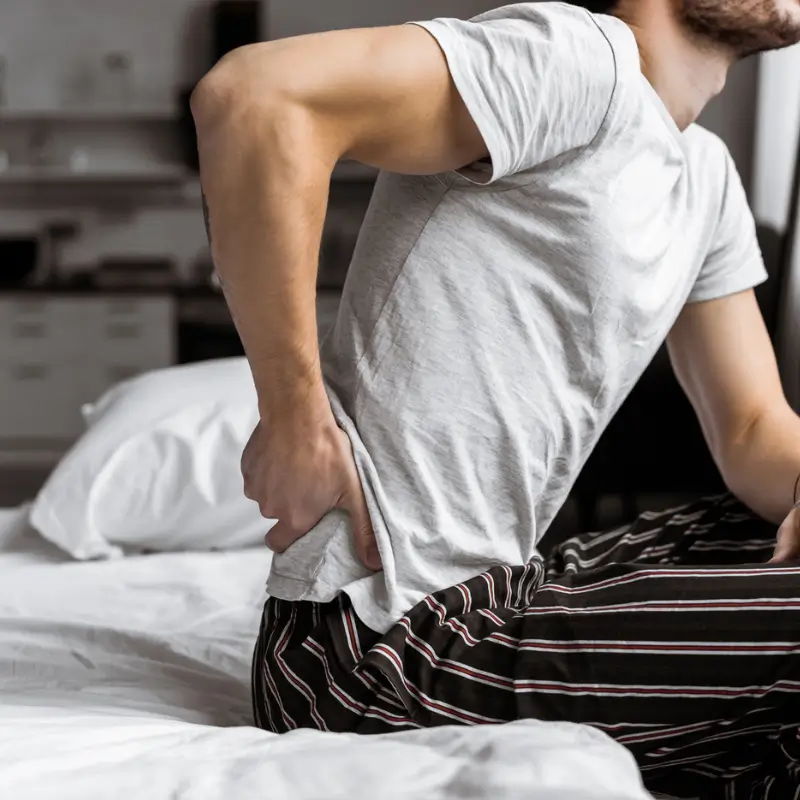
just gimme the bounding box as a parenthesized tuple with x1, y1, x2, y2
(410, 3, 616, 183)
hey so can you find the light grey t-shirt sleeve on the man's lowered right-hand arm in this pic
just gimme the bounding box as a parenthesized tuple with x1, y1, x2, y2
(688, 148, 767, 303)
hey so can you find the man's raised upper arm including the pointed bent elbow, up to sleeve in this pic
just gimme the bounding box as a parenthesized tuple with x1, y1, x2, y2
(198, 25, 488, 174)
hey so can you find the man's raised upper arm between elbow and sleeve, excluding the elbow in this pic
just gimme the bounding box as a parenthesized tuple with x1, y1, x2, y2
(256, 25, 488, 174)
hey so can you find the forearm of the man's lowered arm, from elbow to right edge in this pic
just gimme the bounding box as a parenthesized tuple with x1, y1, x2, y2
(721, 405, 800, 524)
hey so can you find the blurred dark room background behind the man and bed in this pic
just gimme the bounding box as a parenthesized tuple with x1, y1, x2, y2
(0, 0, 800, 535)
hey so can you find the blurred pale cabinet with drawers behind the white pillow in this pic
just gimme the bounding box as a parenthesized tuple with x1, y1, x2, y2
(0, 294, 175, 450)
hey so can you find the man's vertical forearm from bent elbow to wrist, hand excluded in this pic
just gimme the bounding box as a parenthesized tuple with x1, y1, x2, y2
(194, 76, 332, 415)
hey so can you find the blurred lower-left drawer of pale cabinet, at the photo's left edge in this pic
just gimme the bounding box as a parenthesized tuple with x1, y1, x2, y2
(0, 359, 83, 439)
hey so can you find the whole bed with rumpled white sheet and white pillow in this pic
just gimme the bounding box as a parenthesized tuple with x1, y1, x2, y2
(0, 358, 650, 800)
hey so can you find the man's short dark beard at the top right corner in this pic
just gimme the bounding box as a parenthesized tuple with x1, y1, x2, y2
(678, 0, 800, 58)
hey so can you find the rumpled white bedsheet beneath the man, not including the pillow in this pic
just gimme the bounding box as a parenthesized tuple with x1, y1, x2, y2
(0, 513, 650, 800)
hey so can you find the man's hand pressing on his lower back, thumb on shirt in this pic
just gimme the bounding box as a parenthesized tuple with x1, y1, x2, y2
(242, 412, 381, 570)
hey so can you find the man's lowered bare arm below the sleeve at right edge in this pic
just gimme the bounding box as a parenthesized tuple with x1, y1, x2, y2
(668, 290, 800, 556)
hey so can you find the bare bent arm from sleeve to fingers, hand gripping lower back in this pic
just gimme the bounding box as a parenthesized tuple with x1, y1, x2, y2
(192, 25, 487, 566)
